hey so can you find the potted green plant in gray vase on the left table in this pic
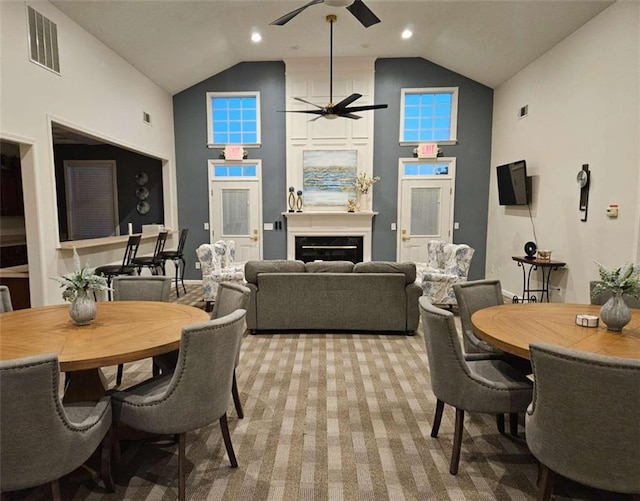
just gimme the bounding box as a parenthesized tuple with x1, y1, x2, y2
(53, 247, 109, 325)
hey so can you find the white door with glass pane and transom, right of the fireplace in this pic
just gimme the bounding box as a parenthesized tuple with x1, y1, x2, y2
(398, 159, 455, 263)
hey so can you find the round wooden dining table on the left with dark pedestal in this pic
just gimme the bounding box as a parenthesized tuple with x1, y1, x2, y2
(0, 301, 210, 402)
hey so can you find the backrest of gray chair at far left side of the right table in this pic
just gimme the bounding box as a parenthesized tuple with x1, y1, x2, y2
(453, 280, 504, 353)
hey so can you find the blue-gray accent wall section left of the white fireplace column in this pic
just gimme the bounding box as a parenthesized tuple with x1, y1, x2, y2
(173, 61, 287, 279)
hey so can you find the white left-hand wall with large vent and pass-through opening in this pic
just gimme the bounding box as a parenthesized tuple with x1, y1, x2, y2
(0, 2, 177, 306)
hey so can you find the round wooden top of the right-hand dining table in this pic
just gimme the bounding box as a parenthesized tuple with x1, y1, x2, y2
(471, 303, 640, 359)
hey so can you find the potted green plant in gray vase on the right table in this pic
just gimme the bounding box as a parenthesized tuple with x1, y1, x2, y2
(592, 263, 640, 332)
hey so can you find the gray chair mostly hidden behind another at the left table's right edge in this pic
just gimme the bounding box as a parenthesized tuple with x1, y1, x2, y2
(153, 282, 251, 419)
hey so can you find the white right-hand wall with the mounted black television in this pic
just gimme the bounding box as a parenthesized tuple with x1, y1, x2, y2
(486, 1, 640, 302)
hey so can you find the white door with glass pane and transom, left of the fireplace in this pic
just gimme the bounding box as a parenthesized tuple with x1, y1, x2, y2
(209, 160, 262, 261)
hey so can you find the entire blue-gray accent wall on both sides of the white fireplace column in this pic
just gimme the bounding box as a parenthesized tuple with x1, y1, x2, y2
(173, 58, 493, 279)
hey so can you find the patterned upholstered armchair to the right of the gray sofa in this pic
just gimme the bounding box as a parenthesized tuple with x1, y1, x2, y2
(416, 240, 475, 305)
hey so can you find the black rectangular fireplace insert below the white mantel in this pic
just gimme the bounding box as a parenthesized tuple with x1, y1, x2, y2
(295, 236, 363, 263)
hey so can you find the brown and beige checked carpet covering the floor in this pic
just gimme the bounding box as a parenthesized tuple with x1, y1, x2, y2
(11, 285, 627, 501)
